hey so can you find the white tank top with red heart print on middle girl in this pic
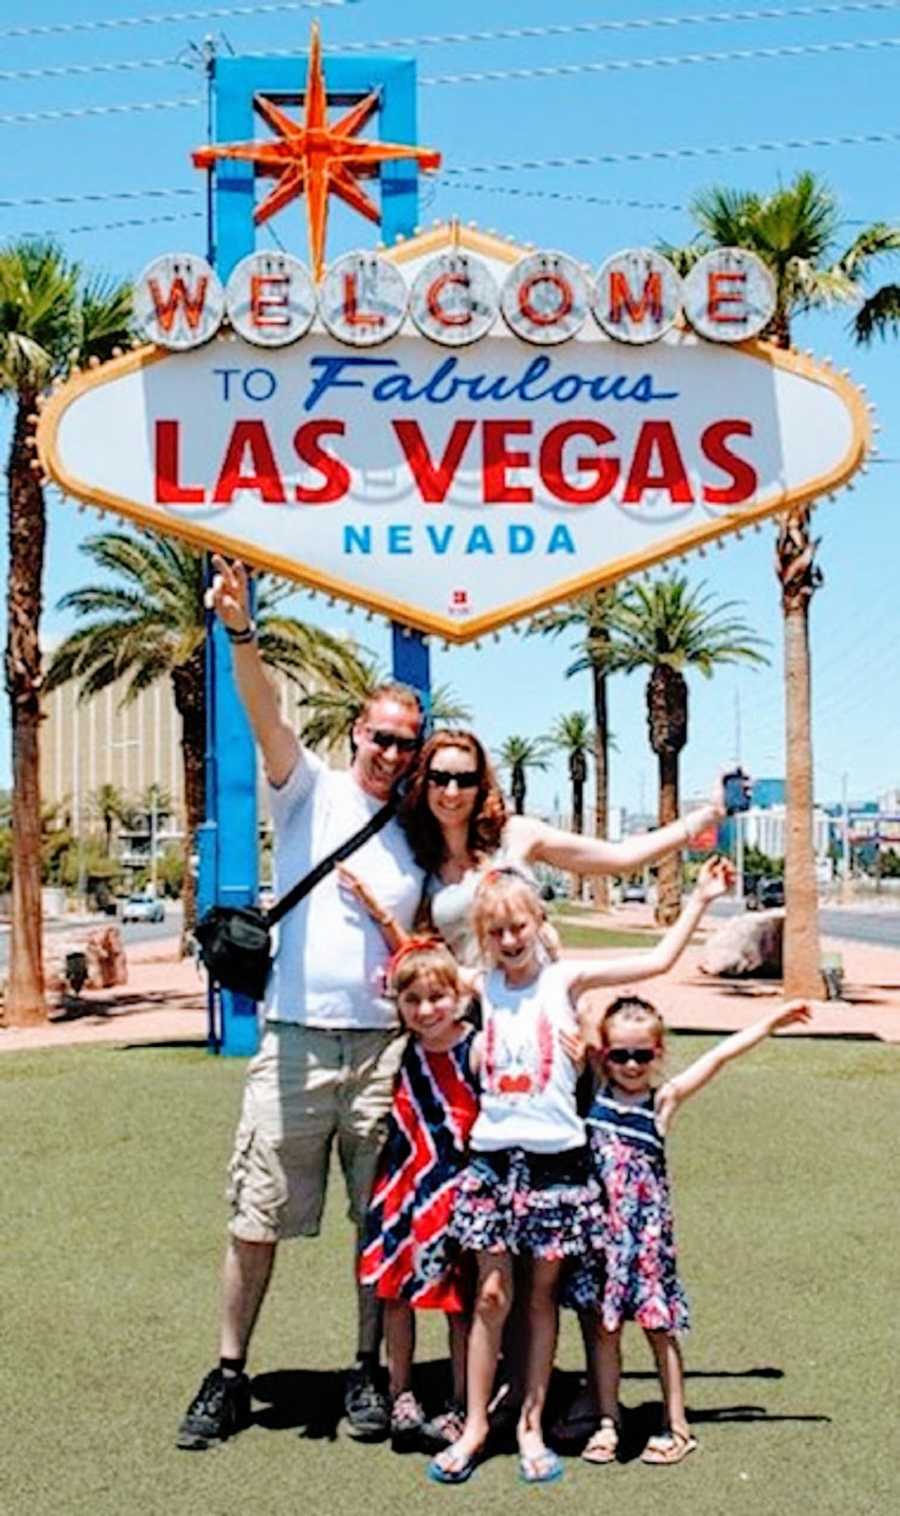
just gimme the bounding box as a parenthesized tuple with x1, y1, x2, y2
(470, 963, 585, 1152)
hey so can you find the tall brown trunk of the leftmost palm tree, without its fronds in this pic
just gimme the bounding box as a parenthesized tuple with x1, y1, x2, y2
(5, 391, 47, 1026)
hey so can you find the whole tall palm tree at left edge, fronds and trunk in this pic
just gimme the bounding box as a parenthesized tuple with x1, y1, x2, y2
(0, 240, 132, 1026)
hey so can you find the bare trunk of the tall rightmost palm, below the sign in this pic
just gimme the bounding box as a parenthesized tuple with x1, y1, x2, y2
(776, 509, 821, 998)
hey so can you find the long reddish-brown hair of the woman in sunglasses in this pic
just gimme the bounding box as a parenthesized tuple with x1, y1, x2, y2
(400, 731, 506, 873)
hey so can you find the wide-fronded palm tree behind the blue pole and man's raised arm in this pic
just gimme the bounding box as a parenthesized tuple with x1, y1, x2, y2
(45, 532, 356, 943)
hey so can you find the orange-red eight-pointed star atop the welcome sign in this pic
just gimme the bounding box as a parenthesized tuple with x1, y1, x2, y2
(191, 24, 441, 279)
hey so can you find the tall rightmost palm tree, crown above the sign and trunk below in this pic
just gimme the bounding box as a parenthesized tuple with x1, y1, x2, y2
(664, 173, 900, 996)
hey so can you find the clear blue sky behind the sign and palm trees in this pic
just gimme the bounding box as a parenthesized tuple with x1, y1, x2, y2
(0, 0, 900, 810)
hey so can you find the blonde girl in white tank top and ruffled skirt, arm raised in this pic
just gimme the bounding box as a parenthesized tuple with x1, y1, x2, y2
(429, 863, 730, 1484)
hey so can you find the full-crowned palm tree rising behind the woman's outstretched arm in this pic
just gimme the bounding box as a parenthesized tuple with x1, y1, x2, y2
(615, 573, 767, 926)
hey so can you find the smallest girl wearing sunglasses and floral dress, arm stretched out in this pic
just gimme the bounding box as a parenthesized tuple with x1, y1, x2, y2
(582, 996, 811, 1464)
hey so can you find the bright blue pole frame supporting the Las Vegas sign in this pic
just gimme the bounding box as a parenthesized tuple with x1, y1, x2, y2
(197, 56, 430, 1057)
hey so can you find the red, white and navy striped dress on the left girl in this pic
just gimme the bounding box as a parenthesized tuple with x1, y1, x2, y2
(359, 1028, 479, 1311)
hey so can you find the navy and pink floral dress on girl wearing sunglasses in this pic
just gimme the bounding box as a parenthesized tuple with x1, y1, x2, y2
(586, 1085, 689, 1333)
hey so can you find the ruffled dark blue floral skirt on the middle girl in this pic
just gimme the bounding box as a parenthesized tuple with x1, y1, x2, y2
(450, 1148, 603, 1261)
